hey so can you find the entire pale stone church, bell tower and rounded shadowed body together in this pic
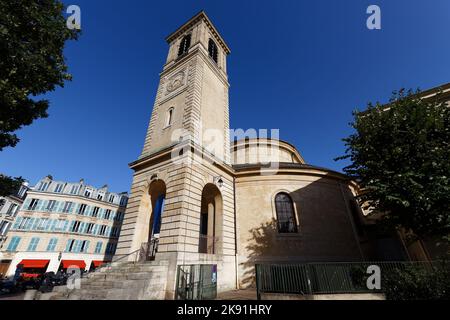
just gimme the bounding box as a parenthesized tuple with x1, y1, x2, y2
(116, 12, 365, 299)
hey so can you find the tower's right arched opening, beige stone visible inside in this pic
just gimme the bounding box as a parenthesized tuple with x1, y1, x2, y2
(198, 183, 223, 254)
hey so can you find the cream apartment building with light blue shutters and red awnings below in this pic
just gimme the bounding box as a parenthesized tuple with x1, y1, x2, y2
(0, 176, 128, 276)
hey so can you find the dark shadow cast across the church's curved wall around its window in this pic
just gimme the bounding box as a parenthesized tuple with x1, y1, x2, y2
(240, 178, 364, 288)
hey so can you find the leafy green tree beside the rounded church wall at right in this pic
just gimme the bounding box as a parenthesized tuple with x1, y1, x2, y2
(336, 90, 450, 244)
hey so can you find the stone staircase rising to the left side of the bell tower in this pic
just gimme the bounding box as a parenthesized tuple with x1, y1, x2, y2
(36, 261, 169, 300)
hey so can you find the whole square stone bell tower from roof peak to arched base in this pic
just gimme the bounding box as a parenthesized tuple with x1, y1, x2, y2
(116, 11, 236, 296)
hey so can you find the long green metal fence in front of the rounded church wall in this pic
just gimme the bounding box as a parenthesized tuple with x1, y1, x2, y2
(255, 261, 439, 299)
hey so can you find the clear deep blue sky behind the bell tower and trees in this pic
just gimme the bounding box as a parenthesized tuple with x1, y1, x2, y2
(0, 0, 450, 191)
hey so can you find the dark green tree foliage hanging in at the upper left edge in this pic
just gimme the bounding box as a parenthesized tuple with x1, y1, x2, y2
(0, 0, 79, 192)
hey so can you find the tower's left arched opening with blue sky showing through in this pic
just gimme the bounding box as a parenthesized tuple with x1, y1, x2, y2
(148, 180, 166, 243)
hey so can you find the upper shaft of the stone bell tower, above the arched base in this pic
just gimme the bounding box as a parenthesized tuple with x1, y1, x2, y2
(141, 12, 230, 162)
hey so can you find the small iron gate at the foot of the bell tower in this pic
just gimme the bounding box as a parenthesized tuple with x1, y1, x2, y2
(175, 264, 217, 300)
